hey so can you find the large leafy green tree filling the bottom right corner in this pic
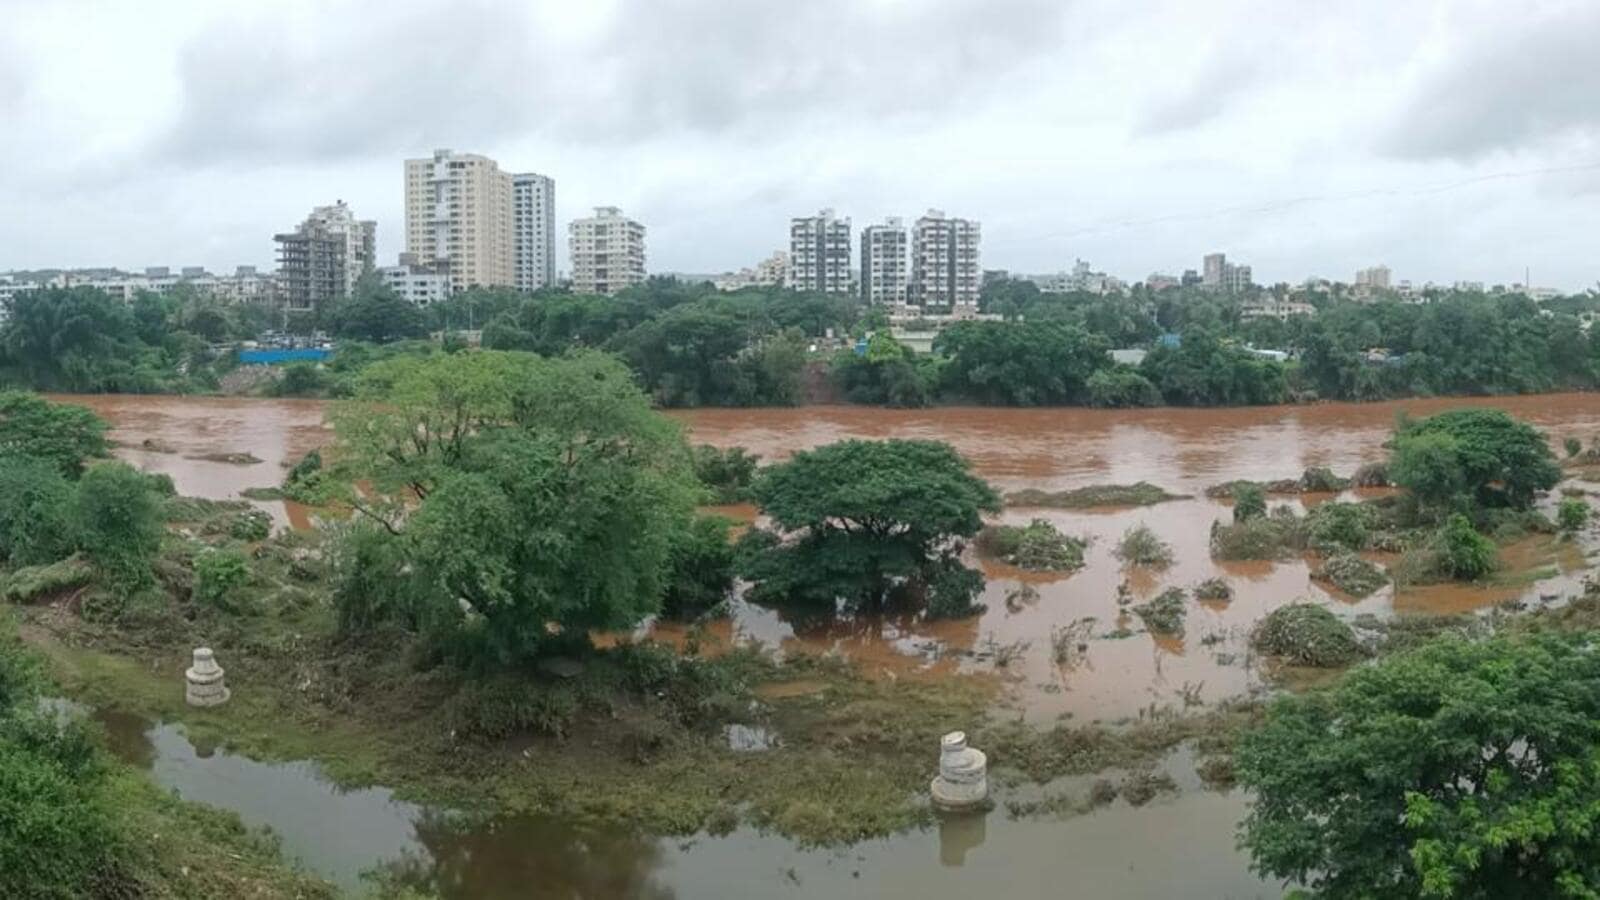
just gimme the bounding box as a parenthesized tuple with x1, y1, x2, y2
(1235, 636, 1600, 898)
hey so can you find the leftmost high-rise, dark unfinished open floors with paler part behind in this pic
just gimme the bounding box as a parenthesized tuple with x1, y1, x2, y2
(272, 200, 378, 312)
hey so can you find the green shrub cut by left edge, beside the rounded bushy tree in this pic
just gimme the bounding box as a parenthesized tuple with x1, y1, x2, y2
(0, 455, 75, 565)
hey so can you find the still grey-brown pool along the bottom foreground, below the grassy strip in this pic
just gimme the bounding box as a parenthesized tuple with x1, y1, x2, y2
(96, 713, 1282, 900)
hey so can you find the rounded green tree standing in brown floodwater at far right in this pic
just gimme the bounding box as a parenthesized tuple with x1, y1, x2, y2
(1389, 408, 1562, 511)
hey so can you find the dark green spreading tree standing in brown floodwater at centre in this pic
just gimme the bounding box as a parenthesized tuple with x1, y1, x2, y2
(741, 440, 1000, 615)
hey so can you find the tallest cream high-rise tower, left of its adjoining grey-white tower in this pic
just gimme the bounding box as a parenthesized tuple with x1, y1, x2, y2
(405, 151, 517, 291)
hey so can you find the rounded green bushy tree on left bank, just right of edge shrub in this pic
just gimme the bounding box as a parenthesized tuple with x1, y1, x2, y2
(72, 463, 163, 594)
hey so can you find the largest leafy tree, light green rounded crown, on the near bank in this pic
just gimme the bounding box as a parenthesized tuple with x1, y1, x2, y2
(324, 351, 699, 665)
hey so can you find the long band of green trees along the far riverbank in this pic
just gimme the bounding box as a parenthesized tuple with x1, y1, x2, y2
(0, 279, 1600, 407)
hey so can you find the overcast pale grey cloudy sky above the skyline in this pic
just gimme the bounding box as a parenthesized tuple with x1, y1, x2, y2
(0, 0, 1600, 290)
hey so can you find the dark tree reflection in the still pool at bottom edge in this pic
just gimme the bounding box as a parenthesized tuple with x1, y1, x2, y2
(376, 812, 675, 900)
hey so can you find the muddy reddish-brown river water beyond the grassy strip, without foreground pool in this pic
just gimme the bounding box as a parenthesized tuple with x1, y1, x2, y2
(62, 394, 1600, 721)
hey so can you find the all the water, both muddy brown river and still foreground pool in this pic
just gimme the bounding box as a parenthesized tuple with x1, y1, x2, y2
(61, 394, 1600, 900)
